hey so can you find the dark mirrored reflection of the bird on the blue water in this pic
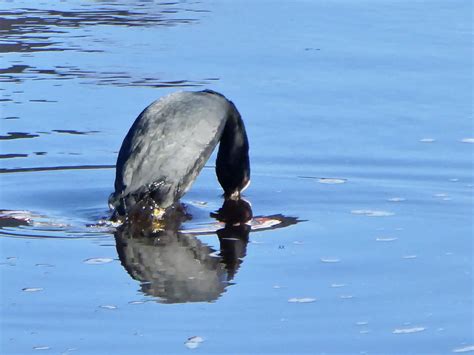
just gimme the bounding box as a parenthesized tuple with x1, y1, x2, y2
(115, 200, 297, 303)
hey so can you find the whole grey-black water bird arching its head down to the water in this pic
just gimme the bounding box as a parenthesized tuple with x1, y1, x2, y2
(110, 91, 250, 214)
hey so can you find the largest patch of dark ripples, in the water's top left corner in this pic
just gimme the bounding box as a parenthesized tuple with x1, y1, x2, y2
(0, 4, 198, 53)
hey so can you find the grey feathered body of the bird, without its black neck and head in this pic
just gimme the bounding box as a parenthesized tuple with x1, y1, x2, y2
(112, 92, 231, 208)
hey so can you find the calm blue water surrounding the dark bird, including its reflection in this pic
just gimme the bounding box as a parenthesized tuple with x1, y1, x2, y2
(0, 0, 474, 354)
